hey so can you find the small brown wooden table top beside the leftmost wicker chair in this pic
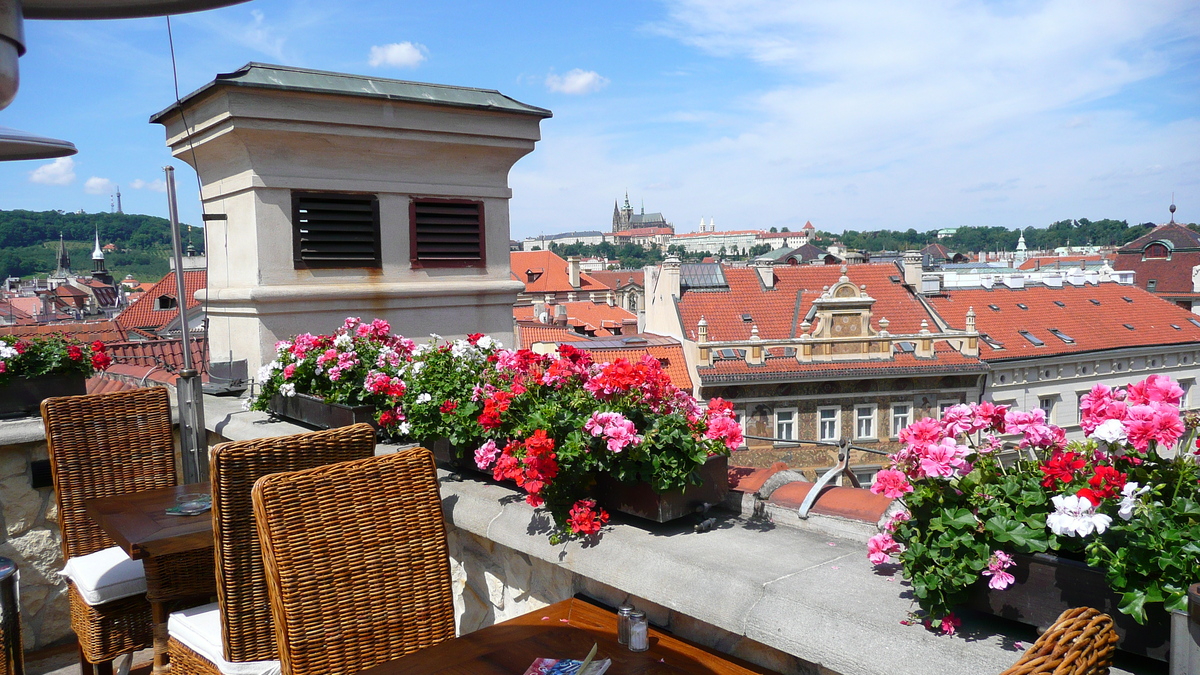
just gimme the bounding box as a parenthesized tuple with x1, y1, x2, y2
(84, 484, 212, 560)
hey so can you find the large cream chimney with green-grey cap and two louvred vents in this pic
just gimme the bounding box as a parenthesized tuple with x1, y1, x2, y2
(151, 64, 551, 372)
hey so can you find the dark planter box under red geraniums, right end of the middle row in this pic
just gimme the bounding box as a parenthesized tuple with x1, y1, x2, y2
(596, 455, 730, 522)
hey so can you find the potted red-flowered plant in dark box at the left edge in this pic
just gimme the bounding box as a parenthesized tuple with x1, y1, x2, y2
(0, 334, 112, 417)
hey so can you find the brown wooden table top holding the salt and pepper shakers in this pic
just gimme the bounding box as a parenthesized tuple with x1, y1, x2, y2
(361, 598, 773, 675)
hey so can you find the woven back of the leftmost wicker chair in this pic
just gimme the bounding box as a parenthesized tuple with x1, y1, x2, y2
(42, 387, 175, 558)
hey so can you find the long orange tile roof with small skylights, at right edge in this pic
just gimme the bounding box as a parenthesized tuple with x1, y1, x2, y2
(930, 282, 1200, 362)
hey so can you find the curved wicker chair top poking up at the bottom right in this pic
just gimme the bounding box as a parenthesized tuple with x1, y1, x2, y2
(1001, 607, 1117, 675)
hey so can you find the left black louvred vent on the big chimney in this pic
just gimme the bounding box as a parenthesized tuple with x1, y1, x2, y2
(292, 192, 383, 269)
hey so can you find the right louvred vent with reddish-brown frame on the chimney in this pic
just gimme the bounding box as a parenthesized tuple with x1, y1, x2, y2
(408, 199, 487, 268)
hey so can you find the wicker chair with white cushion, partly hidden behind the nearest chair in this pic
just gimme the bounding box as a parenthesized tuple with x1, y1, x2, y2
(168, 424, 376, 675)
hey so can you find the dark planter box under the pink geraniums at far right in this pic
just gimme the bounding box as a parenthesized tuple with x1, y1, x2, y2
(967, 554, 1171, 661)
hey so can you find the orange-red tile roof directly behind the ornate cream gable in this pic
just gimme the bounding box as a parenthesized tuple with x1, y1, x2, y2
(679, 263, 934, 341)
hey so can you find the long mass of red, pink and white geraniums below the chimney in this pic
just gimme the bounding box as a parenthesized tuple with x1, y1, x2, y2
(251, 318, 742, 540)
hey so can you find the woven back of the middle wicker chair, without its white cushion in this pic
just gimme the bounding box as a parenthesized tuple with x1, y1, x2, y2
(210, 424, 376, 662)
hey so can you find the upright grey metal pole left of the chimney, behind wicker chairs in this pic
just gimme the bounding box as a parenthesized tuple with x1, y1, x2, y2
(162, 167, 209, 484)
